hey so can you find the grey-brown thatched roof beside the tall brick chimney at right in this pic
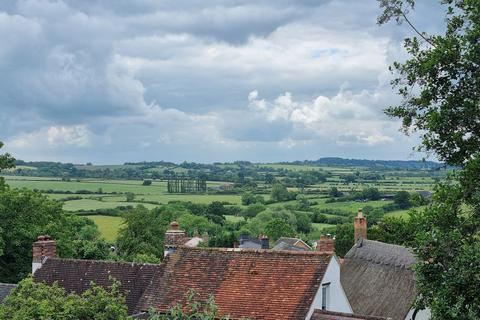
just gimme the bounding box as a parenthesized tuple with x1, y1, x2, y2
(341, 239, 416, 320)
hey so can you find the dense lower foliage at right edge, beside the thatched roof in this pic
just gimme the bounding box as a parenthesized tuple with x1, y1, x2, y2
(410, 164, 480, 320)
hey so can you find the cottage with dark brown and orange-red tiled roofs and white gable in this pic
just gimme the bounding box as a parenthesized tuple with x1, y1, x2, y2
(32, 233, 352, 320)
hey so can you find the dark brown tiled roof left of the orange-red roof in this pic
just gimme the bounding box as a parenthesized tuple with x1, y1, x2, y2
(34, 258, 163, 314)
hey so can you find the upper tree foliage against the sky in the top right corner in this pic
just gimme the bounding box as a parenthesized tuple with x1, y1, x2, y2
(379, 0, 480, 165)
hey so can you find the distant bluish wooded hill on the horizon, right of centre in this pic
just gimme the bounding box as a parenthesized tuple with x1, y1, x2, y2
(282, 157, 445, 170)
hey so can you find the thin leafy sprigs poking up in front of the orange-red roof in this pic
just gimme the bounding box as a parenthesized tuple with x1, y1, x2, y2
(149, 289, 229, 320)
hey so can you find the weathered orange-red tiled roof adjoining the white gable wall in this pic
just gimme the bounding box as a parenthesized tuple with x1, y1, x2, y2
(138, 247, 332, 320)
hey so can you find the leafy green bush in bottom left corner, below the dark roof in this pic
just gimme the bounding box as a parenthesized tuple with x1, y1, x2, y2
(0, 278, 128, 320)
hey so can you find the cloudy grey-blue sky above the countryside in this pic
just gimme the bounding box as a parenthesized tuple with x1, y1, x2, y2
(0, 0, 443, 164)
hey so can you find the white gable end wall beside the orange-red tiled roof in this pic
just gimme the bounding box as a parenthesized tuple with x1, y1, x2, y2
(305, 256, 353, 320)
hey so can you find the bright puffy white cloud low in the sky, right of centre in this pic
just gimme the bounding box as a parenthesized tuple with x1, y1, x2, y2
(244, 90, 398, 146)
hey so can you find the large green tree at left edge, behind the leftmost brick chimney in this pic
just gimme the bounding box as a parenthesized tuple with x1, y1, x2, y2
(0, 188, 108, 282)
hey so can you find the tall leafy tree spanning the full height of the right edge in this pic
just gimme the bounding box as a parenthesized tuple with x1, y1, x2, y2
(378, 0, 480, 320)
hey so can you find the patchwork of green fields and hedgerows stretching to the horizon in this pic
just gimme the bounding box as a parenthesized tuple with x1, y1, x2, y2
(4, 156, 446, 241)
